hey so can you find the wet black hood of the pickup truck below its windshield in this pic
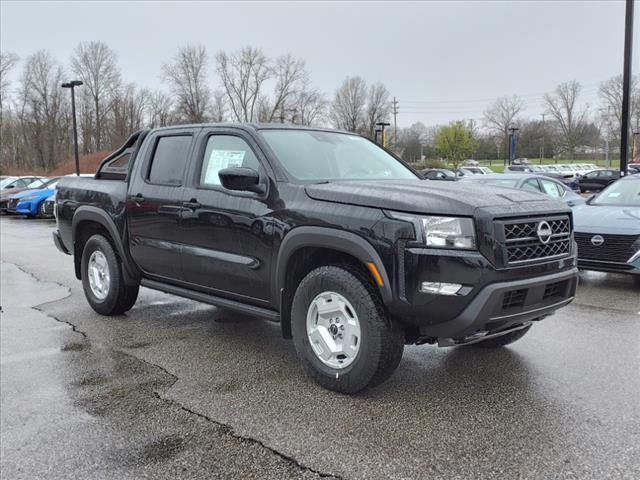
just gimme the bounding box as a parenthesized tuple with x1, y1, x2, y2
(305, 180, 565, 216)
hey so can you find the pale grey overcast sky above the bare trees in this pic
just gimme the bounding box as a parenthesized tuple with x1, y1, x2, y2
(0, 0, 640, 126)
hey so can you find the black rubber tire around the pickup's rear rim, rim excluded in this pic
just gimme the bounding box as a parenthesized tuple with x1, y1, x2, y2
(82, 235, 139, 316)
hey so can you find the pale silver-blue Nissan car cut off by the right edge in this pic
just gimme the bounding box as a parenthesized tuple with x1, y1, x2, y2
(573, 174, 640, 283)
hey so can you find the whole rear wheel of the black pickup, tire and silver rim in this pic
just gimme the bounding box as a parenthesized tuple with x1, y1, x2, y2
(82, 235, 139, 315)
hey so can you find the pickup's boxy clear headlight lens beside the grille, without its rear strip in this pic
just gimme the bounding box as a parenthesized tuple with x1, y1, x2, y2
(422, 217, 476, 250)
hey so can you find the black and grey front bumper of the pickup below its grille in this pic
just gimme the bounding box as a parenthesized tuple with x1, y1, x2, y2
(387, 245, 578, 341)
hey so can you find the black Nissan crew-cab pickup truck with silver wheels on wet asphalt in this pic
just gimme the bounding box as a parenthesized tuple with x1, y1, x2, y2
(54, 124, 577, 393)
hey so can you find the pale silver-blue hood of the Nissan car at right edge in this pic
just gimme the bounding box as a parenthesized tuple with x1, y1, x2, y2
(573, 204, 640, 235)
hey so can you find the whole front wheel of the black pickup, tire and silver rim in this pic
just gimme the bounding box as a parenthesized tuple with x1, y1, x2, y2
(291, 266, 404, 393)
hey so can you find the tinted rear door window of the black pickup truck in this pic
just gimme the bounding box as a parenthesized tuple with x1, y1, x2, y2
(147, 135, 192, 186)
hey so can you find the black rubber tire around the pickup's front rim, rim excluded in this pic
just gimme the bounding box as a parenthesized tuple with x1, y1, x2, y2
(291, 266, 404, 393)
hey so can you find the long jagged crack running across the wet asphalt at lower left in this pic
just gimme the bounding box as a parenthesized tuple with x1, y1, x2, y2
(5, 262, 344, 480)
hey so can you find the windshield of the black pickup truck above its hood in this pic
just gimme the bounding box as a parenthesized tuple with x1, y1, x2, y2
(260, 130, 418, 182)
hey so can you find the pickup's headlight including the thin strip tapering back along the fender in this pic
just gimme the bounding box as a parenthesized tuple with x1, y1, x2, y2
(386, 212, 477, 250)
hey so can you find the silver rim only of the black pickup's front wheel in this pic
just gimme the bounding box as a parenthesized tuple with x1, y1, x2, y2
(307, 291, 362, 369)
